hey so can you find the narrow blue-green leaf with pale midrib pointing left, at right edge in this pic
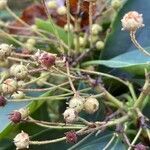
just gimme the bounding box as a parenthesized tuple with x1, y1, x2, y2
(83, 48, 150, 75)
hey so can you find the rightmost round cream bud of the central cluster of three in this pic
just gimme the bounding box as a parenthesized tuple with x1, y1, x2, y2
(84, 96, 99, 114)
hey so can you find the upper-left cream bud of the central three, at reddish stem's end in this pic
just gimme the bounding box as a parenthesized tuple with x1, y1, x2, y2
(69, 95, 85, 113)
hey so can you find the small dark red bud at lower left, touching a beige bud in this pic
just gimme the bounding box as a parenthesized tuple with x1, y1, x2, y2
(9, 111, 21, 124)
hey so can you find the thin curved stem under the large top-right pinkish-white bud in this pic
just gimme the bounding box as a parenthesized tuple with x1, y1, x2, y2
(130, 31, 150, 56)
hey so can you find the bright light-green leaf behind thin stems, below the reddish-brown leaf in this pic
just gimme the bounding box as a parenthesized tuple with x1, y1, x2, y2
(36, 19, 73, 45)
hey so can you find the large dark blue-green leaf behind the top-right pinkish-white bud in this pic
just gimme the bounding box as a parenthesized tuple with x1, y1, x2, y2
(101, 0, 150, 61)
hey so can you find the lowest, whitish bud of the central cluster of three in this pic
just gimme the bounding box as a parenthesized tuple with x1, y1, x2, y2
(63, 108, 77, 123)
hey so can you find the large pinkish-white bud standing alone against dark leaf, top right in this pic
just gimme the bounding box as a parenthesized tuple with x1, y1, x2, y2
(121, 11, 144, 31)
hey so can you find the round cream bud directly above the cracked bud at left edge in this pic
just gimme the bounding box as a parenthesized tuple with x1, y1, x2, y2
(10, 64, 28, 79)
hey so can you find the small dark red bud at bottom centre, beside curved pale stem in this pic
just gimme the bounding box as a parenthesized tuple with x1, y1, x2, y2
(65, 131, 78, 143)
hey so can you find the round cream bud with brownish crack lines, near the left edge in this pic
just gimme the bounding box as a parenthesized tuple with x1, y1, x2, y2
(2, 78, 18, 94)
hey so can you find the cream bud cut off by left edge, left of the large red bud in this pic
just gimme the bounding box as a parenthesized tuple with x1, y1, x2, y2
(0, 43, 12, 60)
